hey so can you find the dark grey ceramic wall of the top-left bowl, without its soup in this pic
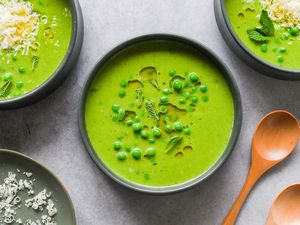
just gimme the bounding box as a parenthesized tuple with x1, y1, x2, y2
(0, 0, 84, 110)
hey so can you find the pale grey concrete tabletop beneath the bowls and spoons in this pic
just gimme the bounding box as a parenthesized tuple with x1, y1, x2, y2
(0, 0, 300, 225)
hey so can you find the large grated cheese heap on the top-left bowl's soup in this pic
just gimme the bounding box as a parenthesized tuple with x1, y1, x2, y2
(0, 0, 40, 54)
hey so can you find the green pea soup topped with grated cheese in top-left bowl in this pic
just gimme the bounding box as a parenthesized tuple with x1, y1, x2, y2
(0, 0, 72, 100)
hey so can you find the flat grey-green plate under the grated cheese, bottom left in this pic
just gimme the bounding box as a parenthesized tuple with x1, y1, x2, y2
(0, 149, 76, 225)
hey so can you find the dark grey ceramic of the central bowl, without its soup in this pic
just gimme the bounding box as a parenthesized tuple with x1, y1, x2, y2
(79, 34, 242, 194)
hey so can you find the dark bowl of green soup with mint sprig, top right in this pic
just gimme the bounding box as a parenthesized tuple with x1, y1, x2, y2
(214, 0, 300, 80)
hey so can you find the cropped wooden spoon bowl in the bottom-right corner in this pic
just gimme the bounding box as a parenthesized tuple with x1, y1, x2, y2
(266, 184, 300, 225)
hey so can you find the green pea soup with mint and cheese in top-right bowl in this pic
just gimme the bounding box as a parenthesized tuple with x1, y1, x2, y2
(225, 0, 300, 70)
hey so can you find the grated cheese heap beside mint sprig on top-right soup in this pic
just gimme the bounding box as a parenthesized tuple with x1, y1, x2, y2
(261, 0, 300, 29)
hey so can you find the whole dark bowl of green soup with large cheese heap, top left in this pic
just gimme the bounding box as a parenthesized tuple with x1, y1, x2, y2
(0, 0, 83, 109)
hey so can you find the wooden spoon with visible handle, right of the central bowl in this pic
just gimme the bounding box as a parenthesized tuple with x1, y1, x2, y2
(223, 110, 300, 225)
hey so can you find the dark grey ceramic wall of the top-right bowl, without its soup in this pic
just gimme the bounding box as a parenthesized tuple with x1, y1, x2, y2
(214, 0, 300, 80)
